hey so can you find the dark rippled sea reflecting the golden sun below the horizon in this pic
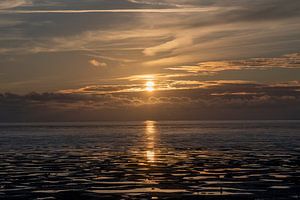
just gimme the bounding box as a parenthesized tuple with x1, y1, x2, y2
(0, 121, 300, 199)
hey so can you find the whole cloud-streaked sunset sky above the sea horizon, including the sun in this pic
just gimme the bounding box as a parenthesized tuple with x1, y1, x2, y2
(0, 0, 300, 122)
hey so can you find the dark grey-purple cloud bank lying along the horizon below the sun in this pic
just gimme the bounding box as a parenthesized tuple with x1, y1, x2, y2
(0, 81, 300, 121)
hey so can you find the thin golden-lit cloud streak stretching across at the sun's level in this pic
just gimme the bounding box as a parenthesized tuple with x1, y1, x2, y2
(59, 78, 299, 96)
